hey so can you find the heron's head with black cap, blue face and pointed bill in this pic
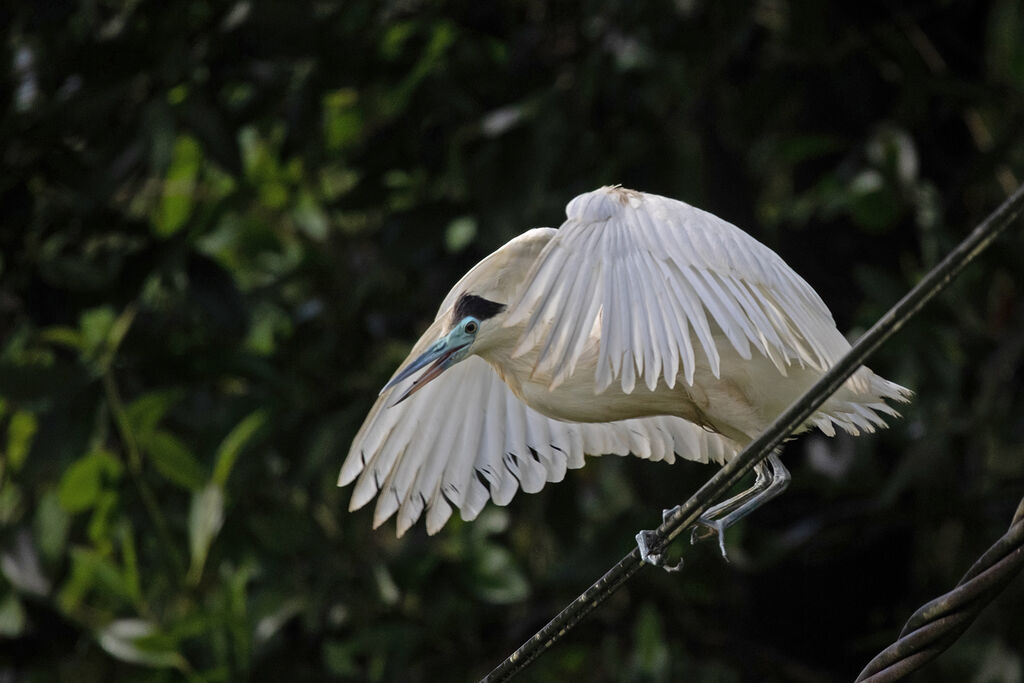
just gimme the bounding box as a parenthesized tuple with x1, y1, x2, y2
(381, 293, 505, 405)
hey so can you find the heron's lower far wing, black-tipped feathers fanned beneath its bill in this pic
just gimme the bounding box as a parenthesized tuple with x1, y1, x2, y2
(338, 315, 738, 536)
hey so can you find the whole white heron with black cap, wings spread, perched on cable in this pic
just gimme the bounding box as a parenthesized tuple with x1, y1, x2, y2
(339, 186, 910, 564)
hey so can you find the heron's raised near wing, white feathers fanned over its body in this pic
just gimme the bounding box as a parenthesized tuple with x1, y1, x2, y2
(504, 187, 866, 393)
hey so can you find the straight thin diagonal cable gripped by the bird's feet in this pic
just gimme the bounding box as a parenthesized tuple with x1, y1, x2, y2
(482, 186, 1024, 683)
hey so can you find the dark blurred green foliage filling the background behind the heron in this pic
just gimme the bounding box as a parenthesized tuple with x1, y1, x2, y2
(0, 0, 1024, 682)
